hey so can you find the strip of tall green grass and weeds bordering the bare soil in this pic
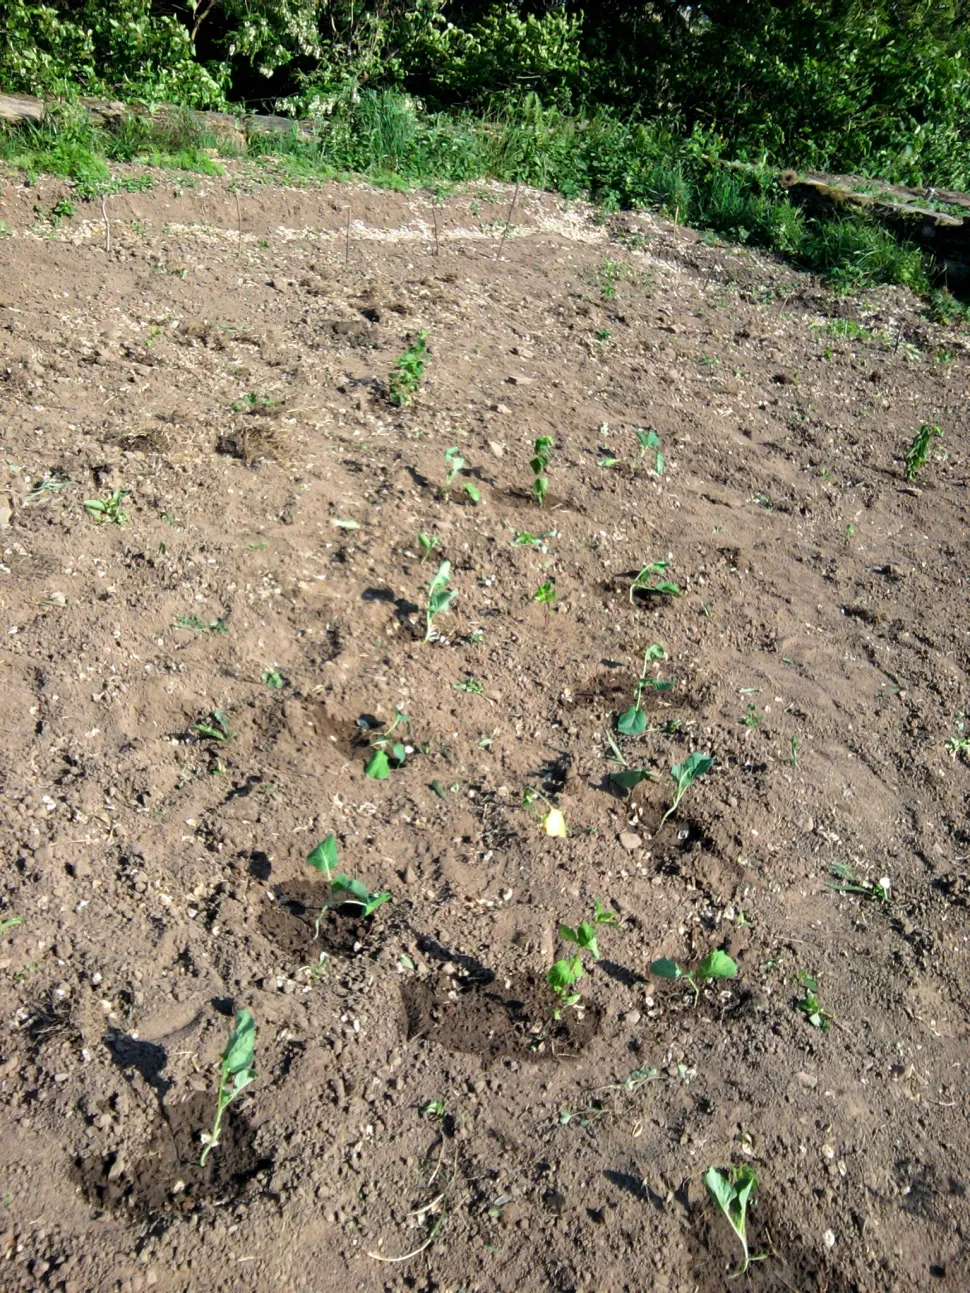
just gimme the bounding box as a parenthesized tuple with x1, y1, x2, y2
(0, 91, 929, 291)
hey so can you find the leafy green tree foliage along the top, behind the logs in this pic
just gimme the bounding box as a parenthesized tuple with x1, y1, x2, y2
(0, 0, 970, 186)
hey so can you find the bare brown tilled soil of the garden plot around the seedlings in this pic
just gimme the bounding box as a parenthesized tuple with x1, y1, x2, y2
(0, 164, 970, 1293)
